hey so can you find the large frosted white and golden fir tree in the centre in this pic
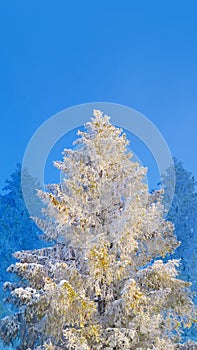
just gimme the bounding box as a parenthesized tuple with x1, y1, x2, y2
(1, 110, 196, 350)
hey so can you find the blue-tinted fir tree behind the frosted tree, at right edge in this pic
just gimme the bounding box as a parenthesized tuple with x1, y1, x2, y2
(163, 158, 197, 341)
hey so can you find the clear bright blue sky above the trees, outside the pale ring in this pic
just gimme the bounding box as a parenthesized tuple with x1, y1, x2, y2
(0, 0, 197, 188)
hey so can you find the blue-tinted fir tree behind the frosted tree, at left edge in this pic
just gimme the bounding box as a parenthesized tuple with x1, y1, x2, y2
(0, 164, 46, 313)
